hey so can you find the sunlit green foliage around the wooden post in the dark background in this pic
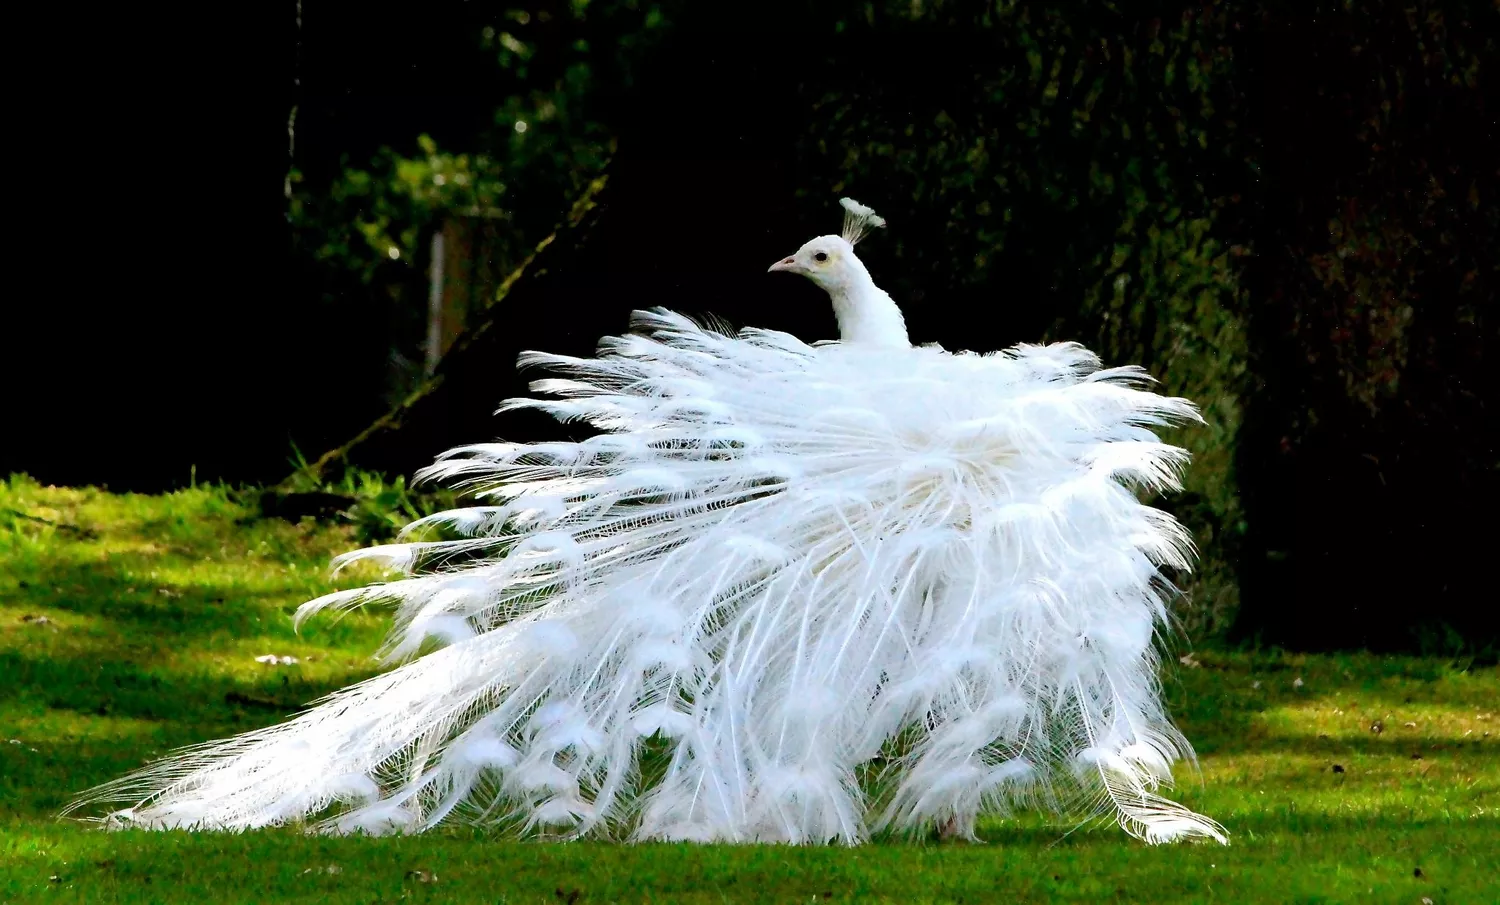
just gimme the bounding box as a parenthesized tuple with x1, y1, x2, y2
(288, 0, 666, 404)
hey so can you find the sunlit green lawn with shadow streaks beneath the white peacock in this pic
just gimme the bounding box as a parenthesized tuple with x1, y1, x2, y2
(0, 479, 1500, 905)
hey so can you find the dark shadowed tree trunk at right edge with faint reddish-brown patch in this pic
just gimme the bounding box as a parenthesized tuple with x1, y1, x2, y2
(1238, 3, 1500, 651)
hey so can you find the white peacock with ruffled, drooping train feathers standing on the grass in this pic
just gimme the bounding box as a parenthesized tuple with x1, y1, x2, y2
(70, 199, 1224, 843)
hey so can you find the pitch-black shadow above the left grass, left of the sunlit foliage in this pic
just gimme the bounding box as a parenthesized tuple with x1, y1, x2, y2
(0, 0, 503, 491)
